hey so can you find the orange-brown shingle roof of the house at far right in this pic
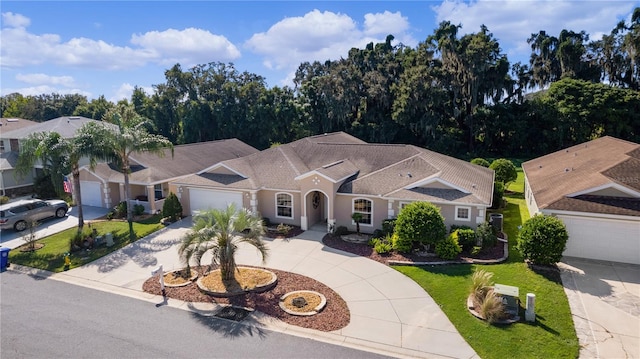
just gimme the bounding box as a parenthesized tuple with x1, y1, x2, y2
(522, 136, 640, 216)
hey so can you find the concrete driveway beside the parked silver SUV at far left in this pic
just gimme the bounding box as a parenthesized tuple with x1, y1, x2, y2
(0, 206, 109, 249)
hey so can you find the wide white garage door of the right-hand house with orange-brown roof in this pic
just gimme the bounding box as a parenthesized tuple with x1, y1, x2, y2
(558, 216, 640, 264)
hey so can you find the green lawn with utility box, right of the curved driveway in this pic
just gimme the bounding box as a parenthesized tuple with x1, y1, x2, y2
(394, 171, 579, 359)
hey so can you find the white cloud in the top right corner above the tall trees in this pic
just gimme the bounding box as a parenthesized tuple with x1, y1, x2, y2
(433, 0, 637, 62)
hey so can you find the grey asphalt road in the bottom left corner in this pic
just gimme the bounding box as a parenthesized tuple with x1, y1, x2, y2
(0, 271, 392, 359)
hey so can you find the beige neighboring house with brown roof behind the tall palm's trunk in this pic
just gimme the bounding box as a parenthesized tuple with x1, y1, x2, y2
(80, 139, 258, 213)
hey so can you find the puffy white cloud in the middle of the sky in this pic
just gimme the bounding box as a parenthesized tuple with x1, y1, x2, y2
(245, 10, 416, 76)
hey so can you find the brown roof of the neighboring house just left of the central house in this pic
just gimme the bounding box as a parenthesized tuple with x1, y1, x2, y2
(85, 138, 258, 184)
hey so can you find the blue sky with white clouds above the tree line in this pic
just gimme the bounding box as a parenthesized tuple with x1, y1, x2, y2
(0, 0, 640, 102)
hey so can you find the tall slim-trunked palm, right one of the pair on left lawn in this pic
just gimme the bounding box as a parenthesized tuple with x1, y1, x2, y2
(78, 104, 173, 239)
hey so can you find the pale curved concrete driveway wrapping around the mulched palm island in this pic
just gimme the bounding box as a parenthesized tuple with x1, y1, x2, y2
(11, 222, 478, 358)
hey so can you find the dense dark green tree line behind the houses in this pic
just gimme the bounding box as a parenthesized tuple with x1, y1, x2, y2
(0, 8, 640, 157)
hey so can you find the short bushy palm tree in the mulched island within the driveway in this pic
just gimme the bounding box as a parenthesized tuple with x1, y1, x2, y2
(178, 204, 268, 280)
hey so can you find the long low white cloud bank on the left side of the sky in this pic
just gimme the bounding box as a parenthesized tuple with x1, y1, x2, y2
(0, 13, 240, 70)
